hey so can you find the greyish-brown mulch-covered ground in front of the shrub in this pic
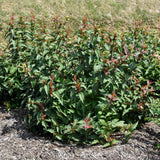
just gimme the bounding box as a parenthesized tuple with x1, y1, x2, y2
(0, 105, 160, 160)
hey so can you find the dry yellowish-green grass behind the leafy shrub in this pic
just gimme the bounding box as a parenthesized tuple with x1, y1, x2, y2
(0, 0, 160, 45)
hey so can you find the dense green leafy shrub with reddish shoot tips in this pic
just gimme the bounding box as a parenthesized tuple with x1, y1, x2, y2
(0, 15, 160, 147)
